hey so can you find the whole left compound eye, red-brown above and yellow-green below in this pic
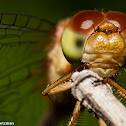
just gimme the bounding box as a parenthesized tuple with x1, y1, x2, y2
(62, 10, 104, 64)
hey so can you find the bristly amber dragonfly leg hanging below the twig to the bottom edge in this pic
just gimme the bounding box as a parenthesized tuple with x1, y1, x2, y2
(67, 101, 83, 126)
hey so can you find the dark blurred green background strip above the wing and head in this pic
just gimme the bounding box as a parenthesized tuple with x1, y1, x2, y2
(0, 0, 126, 22)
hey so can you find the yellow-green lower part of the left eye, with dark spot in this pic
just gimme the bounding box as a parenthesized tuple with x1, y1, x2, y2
(62, 28, 87, 64)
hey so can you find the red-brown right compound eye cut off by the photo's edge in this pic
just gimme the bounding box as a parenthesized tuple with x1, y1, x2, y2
(105, 11, 126, 36)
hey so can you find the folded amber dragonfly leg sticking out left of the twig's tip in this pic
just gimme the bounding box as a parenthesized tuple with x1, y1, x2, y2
(42, 73, 72, 95)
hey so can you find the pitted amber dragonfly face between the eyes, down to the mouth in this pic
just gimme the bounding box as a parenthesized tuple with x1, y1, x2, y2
(82, 22, 126, 77)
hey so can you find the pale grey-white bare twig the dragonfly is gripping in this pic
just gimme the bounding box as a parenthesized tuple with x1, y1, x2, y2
(71, 70, 126, 126)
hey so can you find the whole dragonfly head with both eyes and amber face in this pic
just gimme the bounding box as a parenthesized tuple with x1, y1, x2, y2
(62, 10, 126, 77)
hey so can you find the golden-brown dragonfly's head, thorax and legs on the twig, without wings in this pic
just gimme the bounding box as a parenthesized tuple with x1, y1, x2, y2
(42, 10, 126, 126)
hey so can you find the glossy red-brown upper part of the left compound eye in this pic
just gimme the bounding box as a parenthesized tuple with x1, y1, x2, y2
(68, 10, 105, 35)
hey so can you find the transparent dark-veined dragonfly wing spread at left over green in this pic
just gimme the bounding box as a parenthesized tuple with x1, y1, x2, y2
(0, 13, 54, 126)
